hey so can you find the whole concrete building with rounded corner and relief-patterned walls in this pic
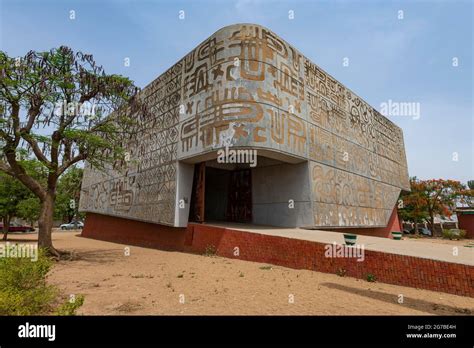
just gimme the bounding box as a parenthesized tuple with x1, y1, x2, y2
(80, 24, 409, 235)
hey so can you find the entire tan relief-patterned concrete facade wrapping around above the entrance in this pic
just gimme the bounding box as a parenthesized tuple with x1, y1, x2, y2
(81, 24, 409, 226)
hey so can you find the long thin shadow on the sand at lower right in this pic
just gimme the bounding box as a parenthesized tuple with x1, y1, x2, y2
(321, 283, 474, 315)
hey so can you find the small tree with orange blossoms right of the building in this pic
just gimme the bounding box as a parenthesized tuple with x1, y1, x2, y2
(399, 177, 465, 233)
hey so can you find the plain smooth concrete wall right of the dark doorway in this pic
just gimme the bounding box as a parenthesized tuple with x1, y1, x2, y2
(252, 162, 314, 227)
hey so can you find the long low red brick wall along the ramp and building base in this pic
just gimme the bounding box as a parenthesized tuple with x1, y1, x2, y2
(82, 214, 474, 297)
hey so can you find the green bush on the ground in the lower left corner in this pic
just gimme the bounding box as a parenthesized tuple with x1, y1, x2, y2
(0, 245, 84, 315)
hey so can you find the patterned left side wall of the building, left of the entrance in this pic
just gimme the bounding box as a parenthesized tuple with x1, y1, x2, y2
(80, 62, 183, 225)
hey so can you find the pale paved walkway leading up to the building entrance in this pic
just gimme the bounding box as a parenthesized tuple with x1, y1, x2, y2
(207, 222, 474, 266)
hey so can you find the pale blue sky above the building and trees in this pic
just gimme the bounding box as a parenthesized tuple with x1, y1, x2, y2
(0, 0, 474, 182)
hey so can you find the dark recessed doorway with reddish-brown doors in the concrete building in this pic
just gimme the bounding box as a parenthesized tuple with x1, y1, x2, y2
(189, 162, 252, 223)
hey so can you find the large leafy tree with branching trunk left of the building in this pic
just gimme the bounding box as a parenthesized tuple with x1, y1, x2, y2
(0, 46, 143, 251)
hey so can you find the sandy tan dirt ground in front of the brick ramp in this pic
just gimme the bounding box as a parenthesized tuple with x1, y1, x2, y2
(1, 231, 474, 315)
